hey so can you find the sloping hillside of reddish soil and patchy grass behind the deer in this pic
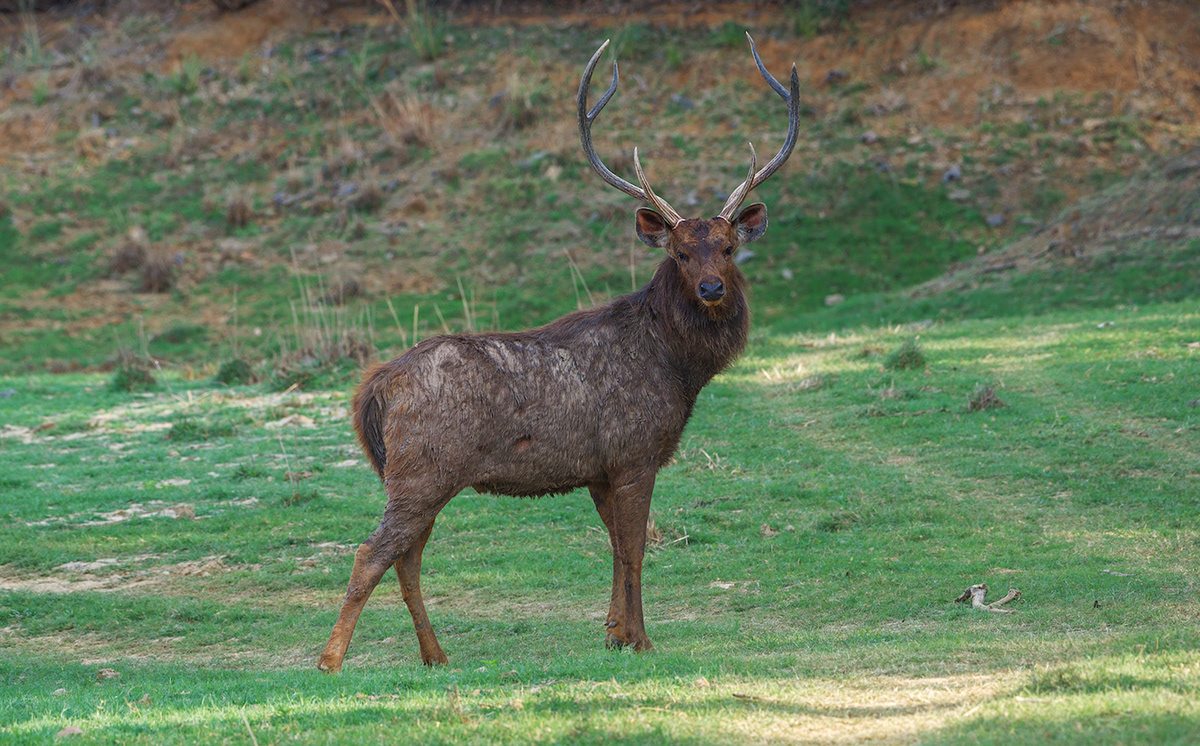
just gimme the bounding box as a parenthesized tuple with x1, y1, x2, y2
(0, 0, 1200, 377)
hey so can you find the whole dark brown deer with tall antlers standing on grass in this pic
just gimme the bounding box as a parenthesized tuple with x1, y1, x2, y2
(317, 34, 799, 673)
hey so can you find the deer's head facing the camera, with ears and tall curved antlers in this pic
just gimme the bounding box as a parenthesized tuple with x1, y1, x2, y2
(578, 34, 800, 314)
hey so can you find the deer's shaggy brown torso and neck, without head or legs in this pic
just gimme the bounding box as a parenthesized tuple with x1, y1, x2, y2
(354, 251, 750, 497)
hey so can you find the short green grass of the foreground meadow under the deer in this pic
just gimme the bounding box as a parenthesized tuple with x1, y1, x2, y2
(0, 279, 1200, 744)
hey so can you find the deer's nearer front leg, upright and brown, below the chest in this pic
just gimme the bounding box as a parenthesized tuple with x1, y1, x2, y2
(606, 468, 655, 652)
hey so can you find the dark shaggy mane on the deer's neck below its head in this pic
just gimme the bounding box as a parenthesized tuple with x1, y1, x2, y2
(634, 259, 750, 393)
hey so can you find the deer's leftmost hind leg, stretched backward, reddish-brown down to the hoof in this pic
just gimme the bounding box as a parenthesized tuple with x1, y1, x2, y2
(317, 489, 457, 673)
